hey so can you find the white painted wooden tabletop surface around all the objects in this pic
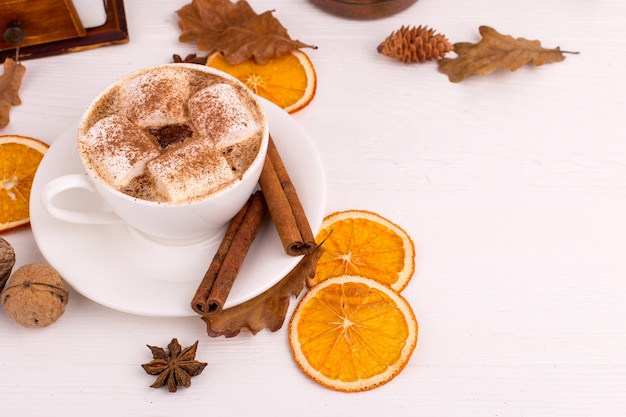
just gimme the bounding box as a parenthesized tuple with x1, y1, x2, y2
(0, 0, 626, 417)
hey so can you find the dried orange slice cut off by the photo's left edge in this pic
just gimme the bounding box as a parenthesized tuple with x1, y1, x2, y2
(0, 135, 48, 232)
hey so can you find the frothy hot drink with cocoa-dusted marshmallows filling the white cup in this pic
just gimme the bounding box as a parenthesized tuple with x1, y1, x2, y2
(78, 65, 264, 204)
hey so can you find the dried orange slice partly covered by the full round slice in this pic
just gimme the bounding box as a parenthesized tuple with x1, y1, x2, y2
(308, 210, 415, 291)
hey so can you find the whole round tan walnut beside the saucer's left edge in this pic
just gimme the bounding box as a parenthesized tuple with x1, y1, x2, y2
(0, 264, 69, 327)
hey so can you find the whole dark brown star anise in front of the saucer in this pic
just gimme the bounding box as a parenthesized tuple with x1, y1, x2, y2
(141, 338, 207, 392)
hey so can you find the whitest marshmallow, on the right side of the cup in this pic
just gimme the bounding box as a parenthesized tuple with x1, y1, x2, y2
(188, 83, 260, 148)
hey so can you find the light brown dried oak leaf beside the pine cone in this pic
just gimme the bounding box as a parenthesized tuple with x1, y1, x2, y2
(439, 26, 565, 83)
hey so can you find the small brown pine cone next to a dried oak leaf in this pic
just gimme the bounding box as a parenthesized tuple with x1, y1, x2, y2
(377, 25, 454, 64)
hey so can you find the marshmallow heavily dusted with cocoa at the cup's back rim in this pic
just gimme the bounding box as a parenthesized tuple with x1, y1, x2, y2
(120, 70, 191, 128)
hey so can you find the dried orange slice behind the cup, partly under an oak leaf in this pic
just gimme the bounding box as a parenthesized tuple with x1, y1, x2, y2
(207, 50, 317, 113)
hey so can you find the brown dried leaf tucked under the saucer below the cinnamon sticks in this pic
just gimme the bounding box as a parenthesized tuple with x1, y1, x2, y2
(202, 245, 324, 337)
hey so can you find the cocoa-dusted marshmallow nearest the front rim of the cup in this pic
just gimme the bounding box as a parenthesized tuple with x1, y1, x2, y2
(147, 137, 236, 203)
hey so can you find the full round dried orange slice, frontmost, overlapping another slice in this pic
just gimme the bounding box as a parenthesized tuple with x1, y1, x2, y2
(289, 275, 418, 392)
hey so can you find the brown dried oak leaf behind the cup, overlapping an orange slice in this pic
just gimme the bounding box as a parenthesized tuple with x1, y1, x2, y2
(176, 0, 315, 64)
